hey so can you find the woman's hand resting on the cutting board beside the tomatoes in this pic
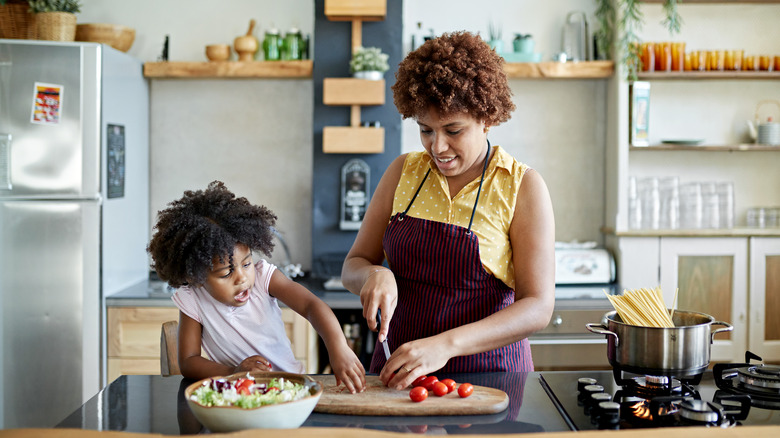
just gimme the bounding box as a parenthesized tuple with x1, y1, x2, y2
(379, 336, 452, 389)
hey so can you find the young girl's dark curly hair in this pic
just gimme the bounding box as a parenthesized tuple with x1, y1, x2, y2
(146, 181, 276, 287)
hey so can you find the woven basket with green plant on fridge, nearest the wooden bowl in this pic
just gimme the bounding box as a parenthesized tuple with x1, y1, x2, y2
(28, 0, 81, 41)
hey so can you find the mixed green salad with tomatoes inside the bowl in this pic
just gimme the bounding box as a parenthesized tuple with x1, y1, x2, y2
(190, 373, 309, 409)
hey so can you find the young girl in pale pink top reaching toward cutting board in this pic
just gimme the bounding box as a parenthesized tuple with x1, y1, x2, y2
(147, 181, 365, 393)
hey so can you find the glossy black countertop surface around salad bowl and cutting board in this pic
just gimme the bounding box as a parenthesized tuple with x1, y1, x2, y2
(56, 372, 570, 435)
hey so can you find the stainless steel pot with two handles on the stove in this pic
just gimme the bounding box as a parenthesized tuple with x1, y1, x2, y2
(585, 310, 734, 376)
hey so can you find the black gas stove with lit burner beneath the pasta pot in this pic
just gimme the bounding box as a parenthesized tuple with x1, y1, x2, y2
(540, 352, 780, 430)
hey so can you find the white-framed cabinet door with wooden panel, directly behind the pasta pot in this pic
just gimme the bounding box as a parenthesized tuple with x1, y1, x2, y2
(660, 237, 748, 362)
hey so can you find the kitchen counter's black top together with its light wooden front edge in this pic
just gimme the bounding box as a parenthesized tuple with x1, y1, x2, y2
(48, 372, 780, 438)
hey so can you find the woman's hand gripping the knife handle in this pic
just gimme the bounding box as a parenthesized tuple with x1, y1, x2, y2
(360, 267, 398, 342)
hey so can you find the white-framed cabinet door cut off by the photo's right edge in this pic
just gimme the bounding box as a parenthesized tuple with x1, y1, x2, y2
(748, 237, 780, 363)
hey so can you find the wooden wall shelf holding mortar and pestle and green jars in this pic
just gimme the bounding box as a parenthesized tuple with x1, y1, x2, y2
(144, 60, 314, 78)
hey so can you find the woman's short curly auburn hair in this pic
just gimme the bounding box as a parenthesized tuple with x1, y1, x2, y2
(392, 32, 515, 126)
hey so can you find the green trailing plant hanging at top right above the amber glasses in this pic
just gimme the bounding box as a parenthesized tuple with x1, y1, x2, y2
(595, 0, 682, 80)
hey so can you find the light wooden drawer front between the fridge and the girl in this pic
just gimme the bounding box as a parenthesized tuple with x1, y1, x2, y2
(108, 307, 179, 358)
